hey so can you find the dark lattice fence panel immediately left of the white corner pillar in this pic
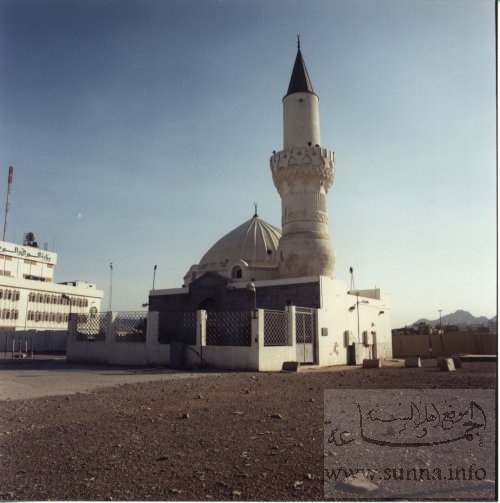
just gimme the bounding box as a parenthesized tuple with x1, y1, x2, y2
(206, 311, 251, 346)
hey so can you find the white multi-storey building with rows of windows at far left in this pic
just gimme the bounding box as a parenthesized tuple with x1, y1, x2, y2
(0, 240, 103, 331)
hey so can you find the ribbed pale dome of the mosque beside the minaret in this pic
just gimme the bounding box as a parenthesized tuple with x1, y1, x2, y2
(184, 213, 281, 285)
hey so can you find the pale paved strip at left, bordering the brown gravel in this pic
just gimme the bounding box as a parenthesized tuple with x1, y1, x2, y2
(0, 357, 223, 401)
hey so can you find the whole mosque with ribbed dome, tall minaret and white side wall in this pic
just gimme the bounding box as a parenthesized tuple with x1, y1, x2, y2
(149, 40, 392, 370)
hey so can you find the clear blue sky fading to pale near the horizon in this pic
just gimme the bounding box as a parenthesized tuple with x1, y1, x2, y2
(0, 0, 497, 328)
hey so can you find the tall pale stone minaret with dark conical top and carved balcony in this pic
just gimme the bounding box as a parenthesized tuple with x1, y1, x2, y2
(270, 39, 335, 278)
